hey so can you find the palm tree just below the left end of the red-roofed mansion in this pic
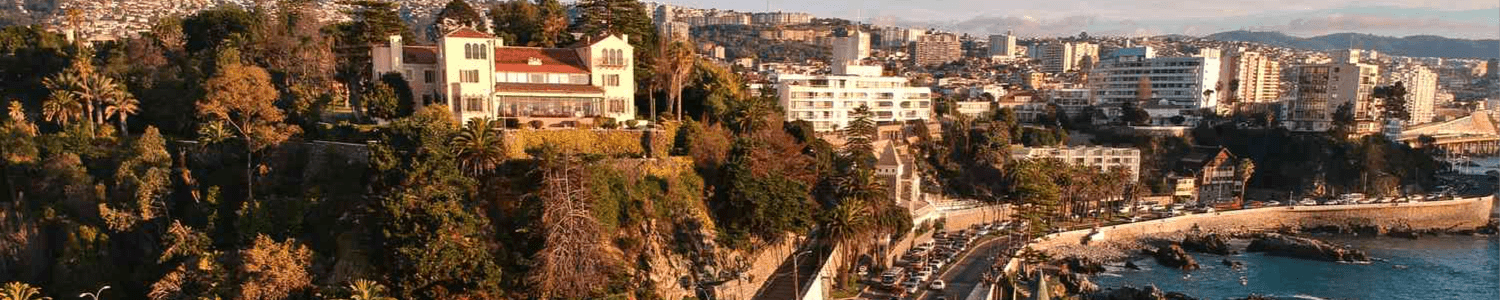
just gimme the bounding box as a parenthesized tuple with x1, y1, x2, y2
(452, 117, 506, 177)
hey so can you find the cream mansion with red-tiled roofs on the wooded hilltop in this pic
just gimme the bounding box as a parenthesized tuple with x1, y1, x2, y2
(371, 29, 636, 125)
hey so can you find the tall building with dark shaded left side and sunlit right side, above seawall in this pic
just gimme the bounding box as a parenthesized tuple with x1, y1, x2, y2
(1284, 50, 1382, 135)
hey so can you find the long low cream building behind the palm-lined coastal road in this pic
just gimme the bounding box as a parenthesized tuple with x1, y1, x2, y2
(1011, 146, 1140, 182)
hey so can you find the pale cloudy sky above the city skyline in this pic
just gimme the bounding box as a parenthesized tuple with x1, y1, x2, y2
(656, 0, 1500, 39)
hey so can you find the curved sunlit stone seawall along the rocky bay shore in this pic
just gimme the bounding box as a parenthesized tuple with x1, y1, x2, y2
(1031, 197, 1496, 251)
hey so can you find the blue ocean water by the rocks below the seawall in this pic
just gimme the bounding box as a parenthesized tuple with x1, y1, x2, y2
(1092, 237, 1500, 300)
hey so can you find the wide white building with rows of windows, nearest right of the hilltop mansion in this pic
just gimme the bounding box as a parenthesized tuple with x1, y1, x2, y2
(776, 70, 933, 132)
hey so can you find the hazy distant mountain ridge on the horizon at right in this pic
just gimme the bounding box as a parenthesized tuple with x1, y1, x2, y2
(1205, 30, 1500, 59)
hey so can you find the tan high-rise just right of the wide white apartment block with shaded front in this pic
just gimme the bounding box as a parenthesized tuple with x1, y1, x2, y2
(1214, 48, 1281, 111)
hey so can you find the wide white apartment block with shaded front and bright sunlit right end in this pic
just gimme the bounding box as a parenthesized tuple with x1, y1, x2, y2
(1089, 47, 1220, 108)
